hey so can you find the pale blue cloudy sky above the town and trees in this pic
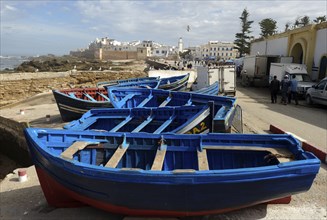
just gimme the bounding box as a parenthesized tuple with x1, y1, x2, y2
(0, 0, 327, 56)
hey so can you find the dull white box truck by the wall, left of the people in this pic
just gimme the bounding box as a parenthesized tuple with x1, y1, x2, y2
(241, 55, 293, 87)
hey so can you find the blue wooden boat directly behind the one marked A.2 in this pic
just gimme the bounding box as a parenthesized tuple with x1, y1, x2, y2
(108, 88, 236, 132)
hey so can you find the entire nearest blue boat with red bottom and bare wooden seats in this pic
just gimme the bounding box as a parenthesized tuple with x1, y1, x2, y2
(25, 128, 320, 217)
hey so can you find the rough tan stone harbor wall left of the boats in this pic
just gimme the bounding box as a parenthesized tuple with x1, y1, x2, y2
(0, 70, 147, 105)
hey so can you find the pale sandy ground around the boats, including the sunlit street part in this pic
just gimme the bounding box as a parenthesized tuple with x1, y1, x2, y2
(0, 85, 327, 220)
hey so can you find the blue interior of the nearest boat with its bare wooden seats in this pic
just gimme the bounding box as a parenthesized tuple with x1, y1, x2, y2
(39, 133, 294, 172)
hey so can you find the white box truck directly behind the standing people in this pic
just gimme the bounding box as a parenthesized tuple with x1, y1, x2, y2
(269, 63, 315, 97)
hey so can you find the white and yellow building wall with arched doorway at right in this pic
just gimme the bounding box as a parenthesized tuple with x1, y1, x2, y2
(250, 22, 327, 80)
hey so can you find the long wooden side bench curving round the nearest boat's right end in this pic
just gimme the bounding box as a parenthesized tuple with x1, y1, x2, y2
(203, 146, 294, 162)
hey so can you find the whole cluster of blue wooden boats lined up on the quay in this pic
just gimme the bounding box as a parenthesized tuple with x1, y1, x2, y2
(25, 75, 320, 216)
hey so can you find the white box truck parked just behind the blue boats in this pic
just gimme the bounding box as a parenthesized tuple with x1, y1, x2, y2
(192, 65, 236, 96)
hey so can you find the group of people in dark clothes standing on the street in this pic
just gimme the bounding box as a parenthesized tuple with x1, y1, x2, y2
(270, 75, 299, 105)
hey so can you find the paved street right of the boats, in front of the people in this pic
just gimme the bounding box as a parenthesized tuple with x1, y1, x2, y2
(236, 83, 327, 152)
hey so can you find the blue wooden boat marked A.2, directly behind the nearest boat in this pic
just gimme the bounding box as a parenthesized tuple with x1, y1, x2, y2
(64, 105, 212, 134)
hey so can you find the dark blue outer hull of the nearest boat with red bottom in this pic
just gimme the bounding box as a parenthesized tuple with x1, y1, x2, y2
(26, 130, 319, 216)
